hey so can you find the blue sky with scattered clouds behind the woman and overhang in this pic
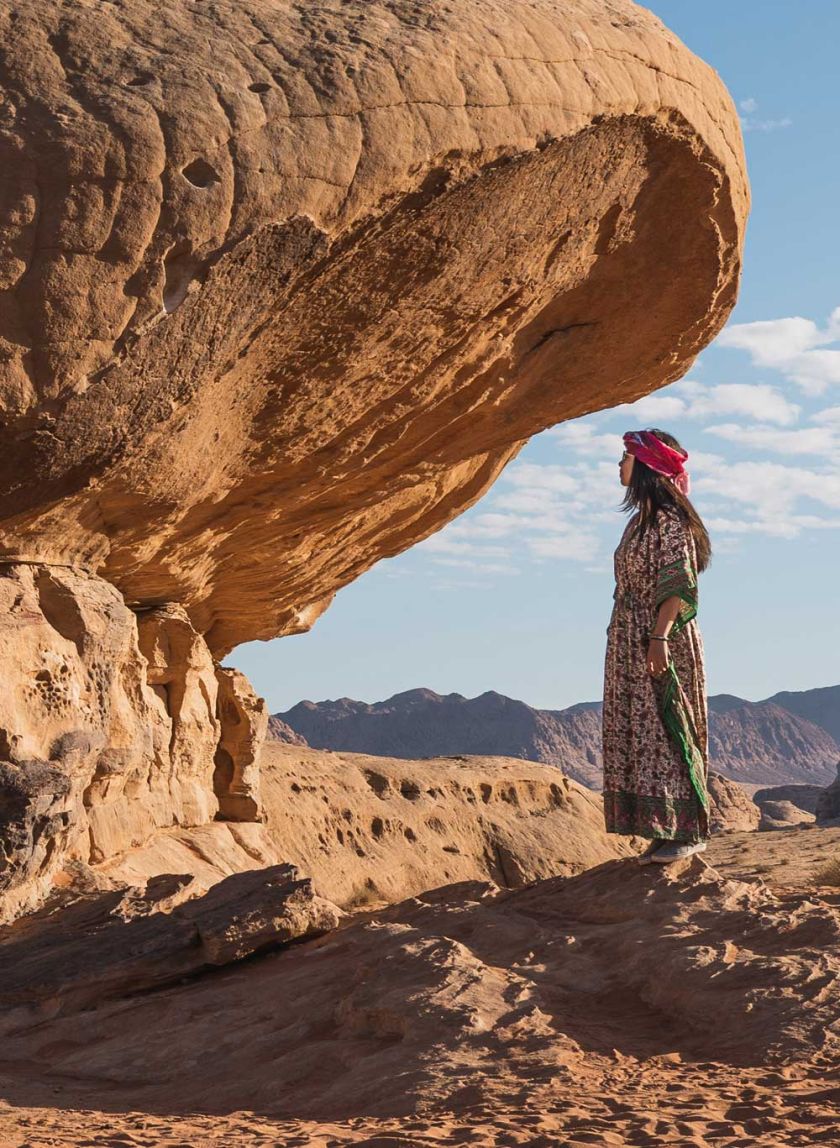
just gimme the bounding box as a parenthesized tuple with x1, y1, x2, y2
(225, 0, 840, 712)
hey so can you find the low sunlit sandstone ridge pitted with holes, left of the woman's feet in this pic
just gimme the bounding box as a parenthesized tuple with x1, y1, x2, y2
(91, 742, 646, 910)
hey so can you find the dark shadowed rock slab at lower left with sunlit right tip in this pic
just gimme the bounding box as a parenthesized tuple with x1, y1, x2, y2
(0, 864, 344, 1016)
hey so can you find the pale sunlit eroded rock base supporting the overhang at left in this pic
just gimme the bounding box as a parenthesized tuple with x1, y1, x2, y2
(0, 564, 266, 920)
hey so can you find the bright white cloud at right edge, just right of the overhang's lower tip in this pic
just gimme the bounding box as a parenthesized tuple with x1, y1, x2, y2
(717, 308, 840, 395)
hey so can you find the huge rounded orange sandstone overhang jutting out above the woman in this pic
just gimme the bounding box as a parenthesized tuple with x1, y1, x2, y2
(0, 0, 748, 657)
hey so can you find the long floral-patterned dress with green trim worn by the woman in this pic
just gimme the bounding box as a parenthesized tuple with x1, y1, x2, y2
(604, 506, 709, 841)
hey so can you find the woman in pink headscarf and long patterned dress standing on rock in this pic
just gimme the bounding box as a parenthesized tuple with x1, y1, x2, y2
(604, 428, 711, 863)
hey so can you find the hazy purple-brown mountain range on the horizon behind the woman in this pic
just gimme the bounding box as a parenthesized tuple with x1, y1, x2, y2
(270, 687, 840, 789)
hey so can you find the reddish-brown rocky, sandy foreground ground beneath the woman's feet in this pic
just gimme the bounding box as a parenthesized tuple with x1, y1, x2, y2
(0, 827, 840, 1148)
